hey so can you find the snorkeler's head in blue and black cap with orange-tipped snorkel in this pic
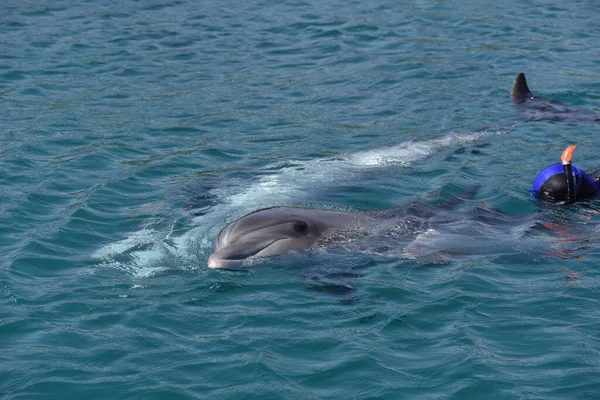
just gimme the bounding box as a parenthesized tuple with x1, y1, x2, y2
(531, 146, 600, 204)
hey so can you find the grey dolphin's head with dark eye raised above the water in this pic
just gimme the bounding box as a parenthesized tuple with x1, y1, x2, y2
(208, 207, 352, 268)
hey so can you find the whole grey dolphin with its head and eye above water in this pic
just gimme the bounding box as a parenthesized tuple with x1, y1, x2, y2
(208, 197, 544, 269)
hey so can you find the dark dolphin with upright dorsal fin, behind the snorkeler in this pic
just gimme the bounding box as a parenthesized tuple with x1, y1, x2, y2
(510, 72, 600, 123)
